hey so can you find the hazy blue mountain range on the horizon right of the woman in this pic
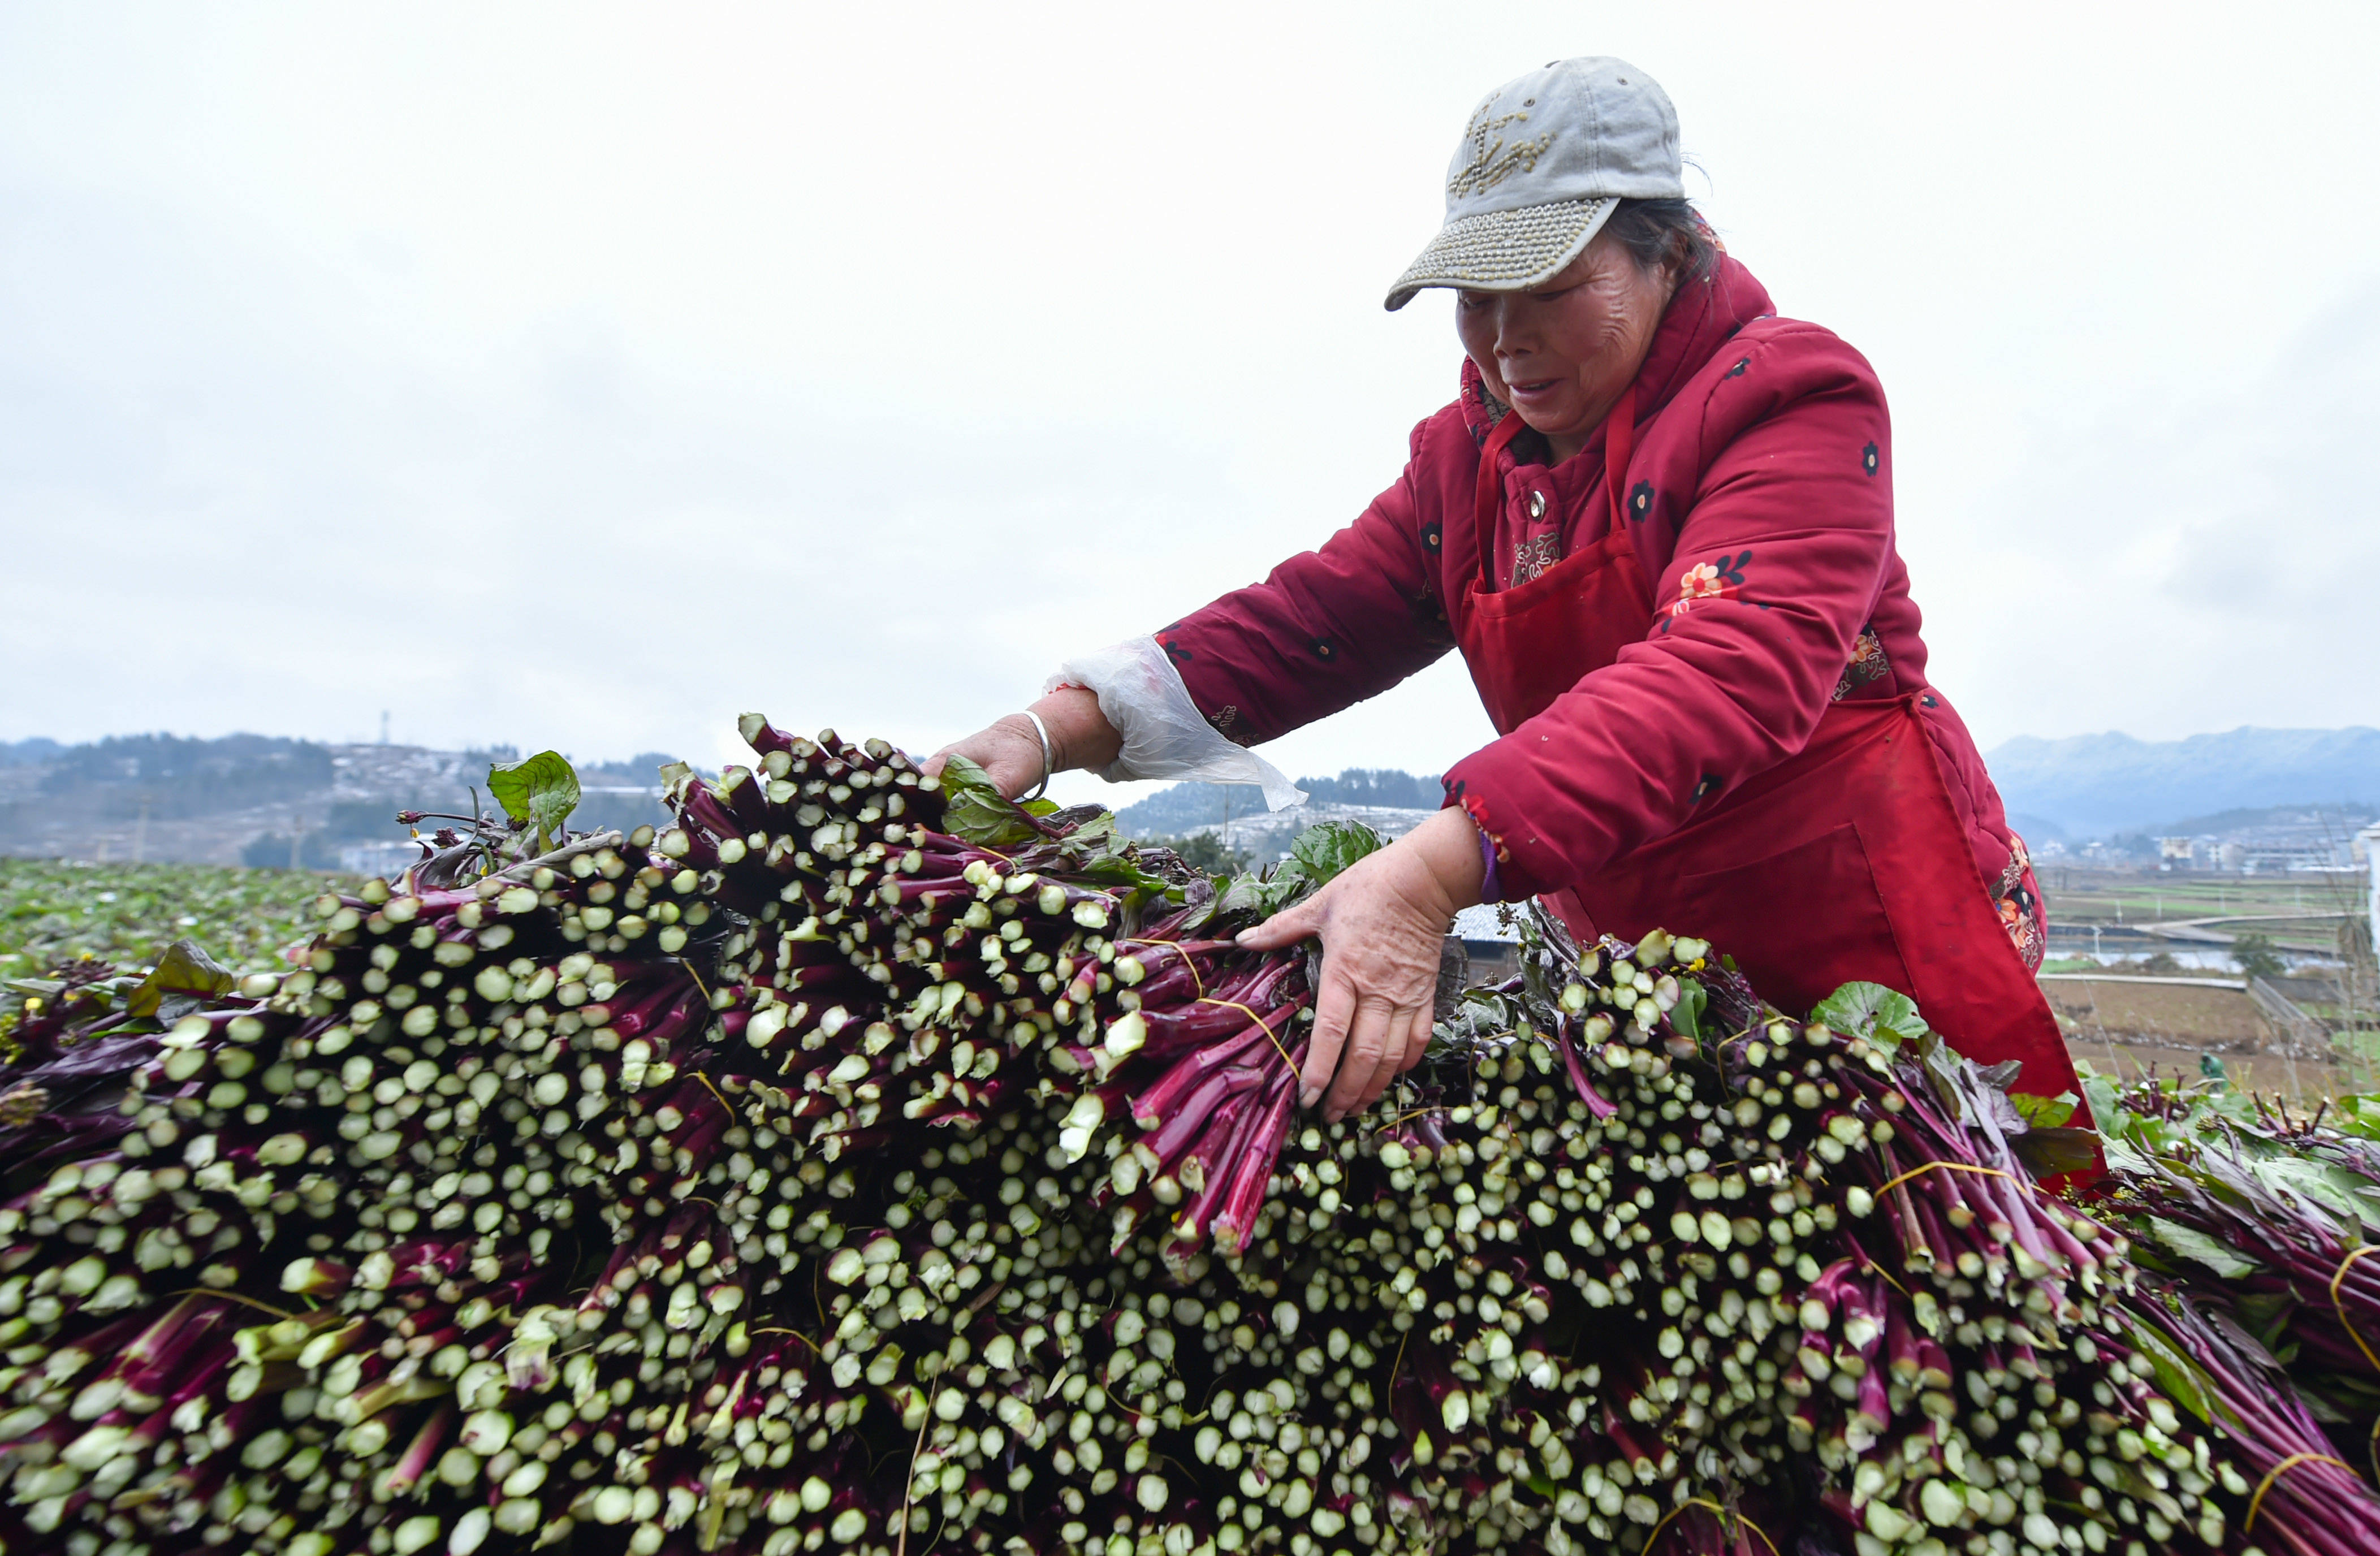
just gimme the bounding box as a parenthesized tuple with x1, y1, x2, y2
(1985, 725, 2380, 837)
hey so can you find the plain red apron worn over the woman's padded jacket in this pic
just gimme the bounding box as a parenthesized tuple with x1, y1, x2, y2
(1447, 402, 2085, 1104)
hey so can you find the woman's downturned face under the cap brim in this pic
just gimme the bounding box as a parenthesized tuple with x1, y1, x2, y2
(1454, 233, 1671, 464)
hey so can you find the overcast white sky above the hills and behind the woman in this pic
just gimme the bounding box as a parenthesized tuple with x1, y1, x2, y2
(0, 0, 2380, 792)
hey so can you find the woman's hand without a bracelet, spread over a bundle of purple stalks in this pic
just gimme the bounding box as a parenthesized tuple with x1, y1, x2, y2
(1240, 806, 1488, 1121)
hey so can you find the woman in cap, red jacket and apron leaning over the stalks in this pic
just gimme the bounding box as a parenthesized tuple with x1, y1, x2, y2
(949, 57, 2073, 1118)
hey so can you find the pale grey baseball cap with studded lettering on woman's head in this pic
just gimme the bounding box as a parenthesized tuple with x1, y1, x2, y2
(1388, 55, 1685, 309)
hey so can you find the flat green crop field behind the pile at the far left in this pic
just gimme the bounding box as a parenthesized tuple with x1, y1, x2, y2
(0, 859, 360, 978)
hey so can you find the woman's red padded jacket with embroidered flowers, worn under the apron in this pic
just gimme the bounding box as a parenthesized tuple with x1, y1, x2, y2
(1157, 257, 2040, 937)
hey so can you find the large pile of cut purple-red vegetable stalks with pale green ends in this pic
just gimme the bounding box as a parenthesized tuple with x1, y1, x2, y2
(0, 719, 2380, 1556)
